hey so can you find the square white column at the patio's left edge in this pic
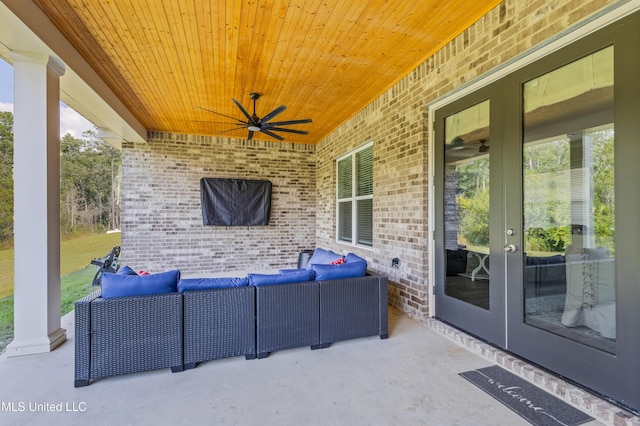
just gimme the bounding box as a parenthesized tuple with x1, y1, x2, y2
(7, 52, 66, 356)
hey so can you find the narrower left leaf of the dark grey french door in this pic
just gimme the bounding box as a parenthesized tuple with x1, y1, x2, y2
(435, 87, 506, 347)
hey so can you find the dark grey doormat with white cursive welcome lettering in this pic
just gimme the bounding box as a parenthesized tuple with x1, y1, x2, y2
(460, 365, 593, 426)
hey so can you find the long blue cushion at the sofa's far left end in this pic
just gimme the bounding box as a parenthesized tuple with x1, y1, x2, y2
(100, 269, 180, 299)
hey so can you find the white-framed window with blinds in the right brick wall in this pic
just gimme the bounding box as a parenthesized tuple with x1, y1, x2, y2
(336, 142, 373, 247)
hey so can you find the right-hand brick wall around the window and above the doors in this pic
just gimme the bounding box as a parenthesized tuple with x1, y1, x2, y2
(316, 0, 615, 321)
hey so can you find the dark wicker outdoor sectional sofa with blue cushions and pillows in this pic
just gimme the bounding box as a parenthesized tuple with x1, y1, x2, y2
(75, 249, 389, 387)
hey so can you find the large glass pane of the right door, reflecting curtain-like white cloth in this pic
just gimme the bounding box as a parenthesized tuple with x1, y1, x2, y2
(522, 47, 616, 353)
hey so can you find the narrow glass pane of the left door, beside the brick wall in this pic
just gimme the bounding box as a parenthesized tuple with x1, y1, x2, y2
(443, 100, 490, 310)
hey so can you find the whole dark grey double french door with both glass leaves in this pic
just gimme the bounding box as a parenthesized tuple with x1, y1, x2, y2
(434, 13, 640, 409)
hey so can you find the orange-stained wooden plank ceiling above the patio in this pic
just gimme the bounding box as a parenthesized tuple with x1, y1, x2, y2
(34, 0, 500, 143)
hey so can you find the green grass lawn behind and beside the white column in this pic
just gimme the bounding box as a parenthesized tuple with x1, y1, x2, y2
(0, 233, 120, 353)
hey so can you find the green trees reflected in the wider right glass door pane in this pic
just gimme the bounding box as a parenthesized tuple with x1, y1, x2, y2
(524, 129, 615, 253)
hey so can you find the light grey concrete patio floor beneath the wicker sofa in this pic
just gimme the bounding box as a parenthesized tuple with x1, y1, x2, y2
(0, 309, 640, 426)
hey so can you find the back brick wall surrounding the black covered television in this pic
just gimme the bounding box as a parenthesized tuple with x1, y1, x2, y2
(122, 133, 316, 276)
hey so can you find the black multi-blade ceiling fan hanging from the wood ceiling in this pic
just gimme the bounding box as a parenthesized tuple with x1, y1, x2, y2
(198, 93, 312, 141)
